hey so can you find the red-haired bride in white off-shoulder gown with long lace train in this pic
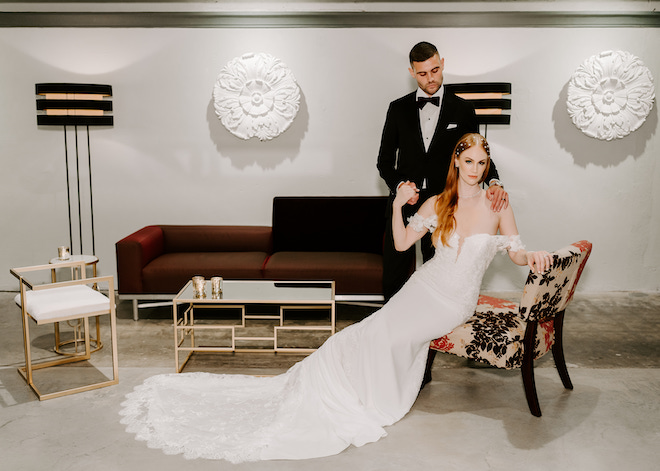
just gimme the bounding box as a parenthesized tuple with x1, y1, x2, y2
(121, 134, 549, 463)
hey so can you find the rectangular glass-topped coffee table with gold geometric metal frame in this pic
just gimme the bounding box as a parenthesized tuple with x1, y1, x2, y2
(172, 280, 336, 373)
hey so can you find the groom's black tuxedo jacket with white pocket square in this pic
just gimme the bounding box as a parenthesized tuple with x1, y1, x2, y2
(378, 90, 498, 196)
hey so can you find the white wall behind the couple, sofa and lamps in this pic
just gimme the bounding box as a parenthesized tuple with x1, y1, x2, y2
(0, 24, 660, 292)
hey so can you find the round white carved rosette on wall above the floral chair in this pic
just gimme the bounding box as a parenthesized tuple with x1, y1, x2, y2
(566, 51, 655, 141)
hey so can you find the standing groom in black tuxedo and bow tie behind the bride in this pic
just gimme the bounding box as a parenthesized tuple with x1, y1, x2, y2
(377, 42, 508, 301)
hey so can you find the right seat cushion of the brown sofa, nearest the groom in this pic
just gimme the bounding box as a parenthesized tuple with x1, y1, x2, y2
(264, 252, 383, 294)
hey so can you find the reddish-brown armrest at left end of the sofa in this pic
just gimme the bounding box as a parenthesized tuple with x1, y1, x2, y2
(115, 226, 165, 294)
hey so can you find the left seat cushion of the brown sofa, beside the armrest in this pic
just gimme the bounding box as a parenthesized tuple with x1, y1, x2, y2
(142, 252, 268, 294)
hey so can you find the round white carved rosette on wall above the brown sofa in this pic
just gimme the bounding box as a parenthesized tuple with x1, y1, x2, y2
(213, 53, 300, 141)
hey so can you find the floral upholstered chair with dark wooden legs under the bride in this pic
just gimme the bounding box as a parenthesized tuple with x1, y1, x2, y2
(424, 240, 591, 417)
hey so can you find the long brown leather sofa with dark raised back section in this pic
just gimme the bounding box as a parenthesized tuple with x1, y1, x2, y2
(116, 196, 387, 320)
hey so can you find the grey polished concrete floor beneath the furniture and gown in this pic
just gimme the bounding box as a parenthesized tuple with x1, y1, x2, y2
(0, 292, 660, 471)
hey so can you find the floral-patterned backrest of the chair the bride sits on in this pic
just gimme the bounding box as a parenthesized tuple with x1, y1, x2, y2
(520, 240, 592, 321)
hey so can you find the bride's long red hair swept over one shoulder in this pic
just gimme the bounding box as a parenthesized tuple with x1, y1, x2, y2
(432, 133, 490, 247)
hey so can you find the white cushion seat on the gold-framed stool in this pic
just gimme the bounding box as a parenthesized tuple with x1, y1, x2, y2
(14, 285, 110, 324)
